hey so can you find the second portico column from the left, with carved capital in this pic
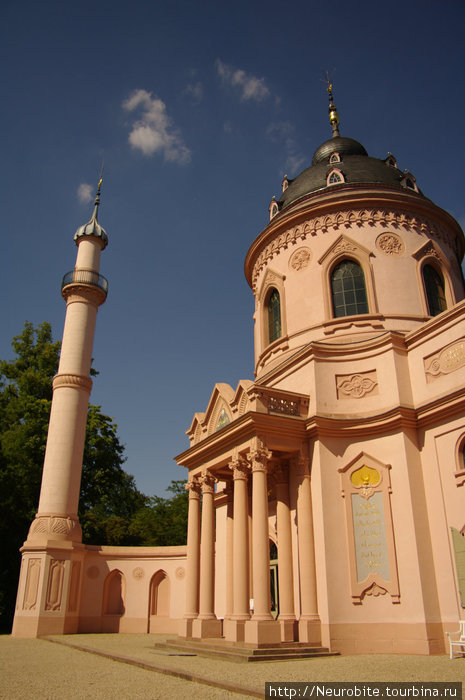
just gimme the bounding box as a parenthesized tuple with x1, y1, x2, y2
(192, 469, 221, 638)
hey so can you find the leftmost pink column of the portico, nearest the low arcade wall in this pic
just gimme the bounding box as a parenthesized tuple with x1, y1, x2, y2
(180, 477, 200, 637)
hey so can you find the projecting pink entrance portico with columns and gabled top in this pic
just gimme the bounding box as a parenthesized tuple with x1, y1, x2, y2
(178, 386, 321, 645)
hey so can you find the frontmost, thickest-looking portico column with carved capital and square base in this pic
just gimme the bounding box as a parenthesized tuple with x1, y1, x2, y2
(245, 438, 281, 644)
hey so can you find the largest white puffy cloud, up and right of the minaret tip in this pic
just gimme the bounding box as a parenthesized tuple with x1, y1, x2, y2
(122, 90, 191, 165)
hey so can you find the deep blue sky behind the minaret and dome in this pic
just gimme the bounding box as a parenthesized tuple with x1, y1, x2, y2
(0, 0, 465, 495)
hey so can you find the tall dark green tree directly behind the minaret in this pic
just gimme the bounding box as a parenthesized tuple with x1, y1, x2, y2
(0, 322, 147, 629)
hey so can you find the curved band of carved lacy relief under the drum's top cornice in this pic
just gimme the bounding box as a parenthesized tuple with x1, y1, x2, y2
(252, 209, 453, 292)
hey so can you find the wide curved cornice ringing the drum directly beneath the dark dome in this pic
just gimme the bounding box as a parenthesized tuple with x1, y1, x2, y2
(244, 186, 465, 289)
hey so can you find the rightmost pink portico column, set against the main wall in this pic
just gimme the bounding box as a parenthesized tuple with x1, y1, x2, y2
(295, 453, 321, 644)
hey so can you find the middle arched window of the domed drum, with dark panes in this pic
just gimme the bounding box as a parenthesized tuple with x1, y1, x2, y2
(331, 260, 368, 318)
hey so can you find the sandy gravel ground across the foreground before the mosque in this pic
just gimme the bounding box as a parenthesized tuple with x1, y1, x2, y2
(0, 634, 465, 700)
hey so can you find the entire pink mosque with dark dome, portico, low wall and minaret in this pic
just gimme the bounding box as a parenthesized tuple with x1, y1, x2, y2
(13, 85, 465, 654)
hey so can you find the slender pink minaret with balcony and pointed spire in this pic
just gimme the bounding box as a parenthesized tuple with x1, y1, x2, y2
(13, 179, 108, 637)
